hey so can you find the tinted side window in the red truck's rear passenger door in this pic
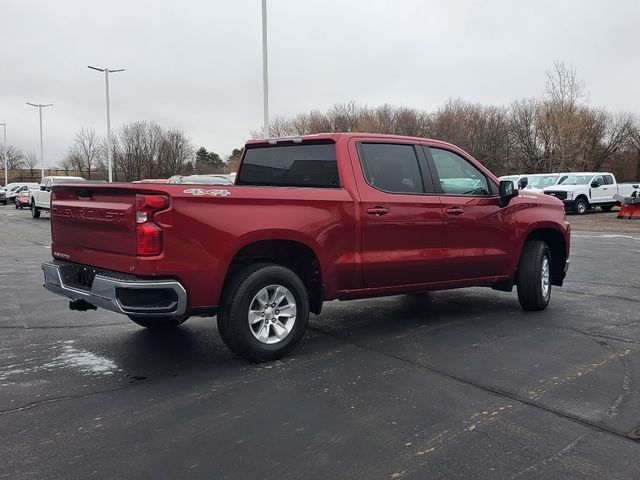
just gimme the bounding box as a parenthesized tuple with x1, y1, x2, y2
(359, 143, 424, 193)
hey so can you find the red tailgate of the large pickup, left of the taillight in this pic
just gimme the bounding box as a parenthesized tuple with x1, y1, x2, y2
(51, 184, 136, 256)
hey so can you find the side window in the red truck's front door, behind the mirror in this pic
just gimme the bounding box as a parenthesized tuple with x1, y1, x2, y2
(429, 148, 491, 196)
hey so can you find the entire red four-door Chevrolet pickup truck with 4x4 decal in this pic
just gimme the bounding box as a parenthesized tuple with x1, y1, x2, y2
(42, 133, 570, 361)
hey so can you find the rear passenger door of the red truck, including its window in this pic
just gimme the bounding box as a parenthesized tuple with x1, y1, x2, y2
(349, 139, 442, 288)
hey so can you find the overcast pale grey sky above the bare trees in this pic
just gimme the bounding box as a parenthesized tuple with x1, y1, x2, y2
(0, 0, 640, 164)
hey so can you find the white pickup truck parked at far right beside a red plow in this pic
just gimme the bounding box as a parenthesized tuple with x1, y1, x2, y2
(544, 172, 632, 215)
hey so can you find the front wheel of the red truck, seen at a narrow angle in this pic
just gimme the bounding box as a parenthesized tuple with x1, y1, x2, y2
(517, 240, 552, 311)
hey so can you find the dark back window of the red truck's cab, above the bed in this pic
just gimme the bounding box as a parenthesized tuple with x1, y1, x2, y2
(236, 143, 340, 188)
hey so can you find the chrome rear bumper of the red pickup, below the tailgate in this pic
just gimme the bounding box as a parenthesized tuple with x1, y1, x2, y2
(42, 260, 187, 317)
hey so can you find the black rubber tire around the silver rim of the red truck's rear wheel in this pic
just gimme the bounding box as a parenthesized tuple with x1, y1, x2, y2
(218, 263, 309, 362)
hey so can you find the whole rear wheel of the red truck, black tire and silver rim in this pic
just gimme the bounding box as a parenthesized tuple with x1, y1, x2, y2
(218, 263, 309, 362)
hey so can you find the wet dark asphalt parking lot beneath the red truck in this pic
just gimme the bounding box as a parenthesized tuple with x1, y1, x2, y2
(0, 207, 640, 479)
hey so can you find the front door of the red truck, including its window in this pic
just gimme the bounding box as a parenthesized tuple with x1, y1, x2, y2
(424, 146, 516, 280)
